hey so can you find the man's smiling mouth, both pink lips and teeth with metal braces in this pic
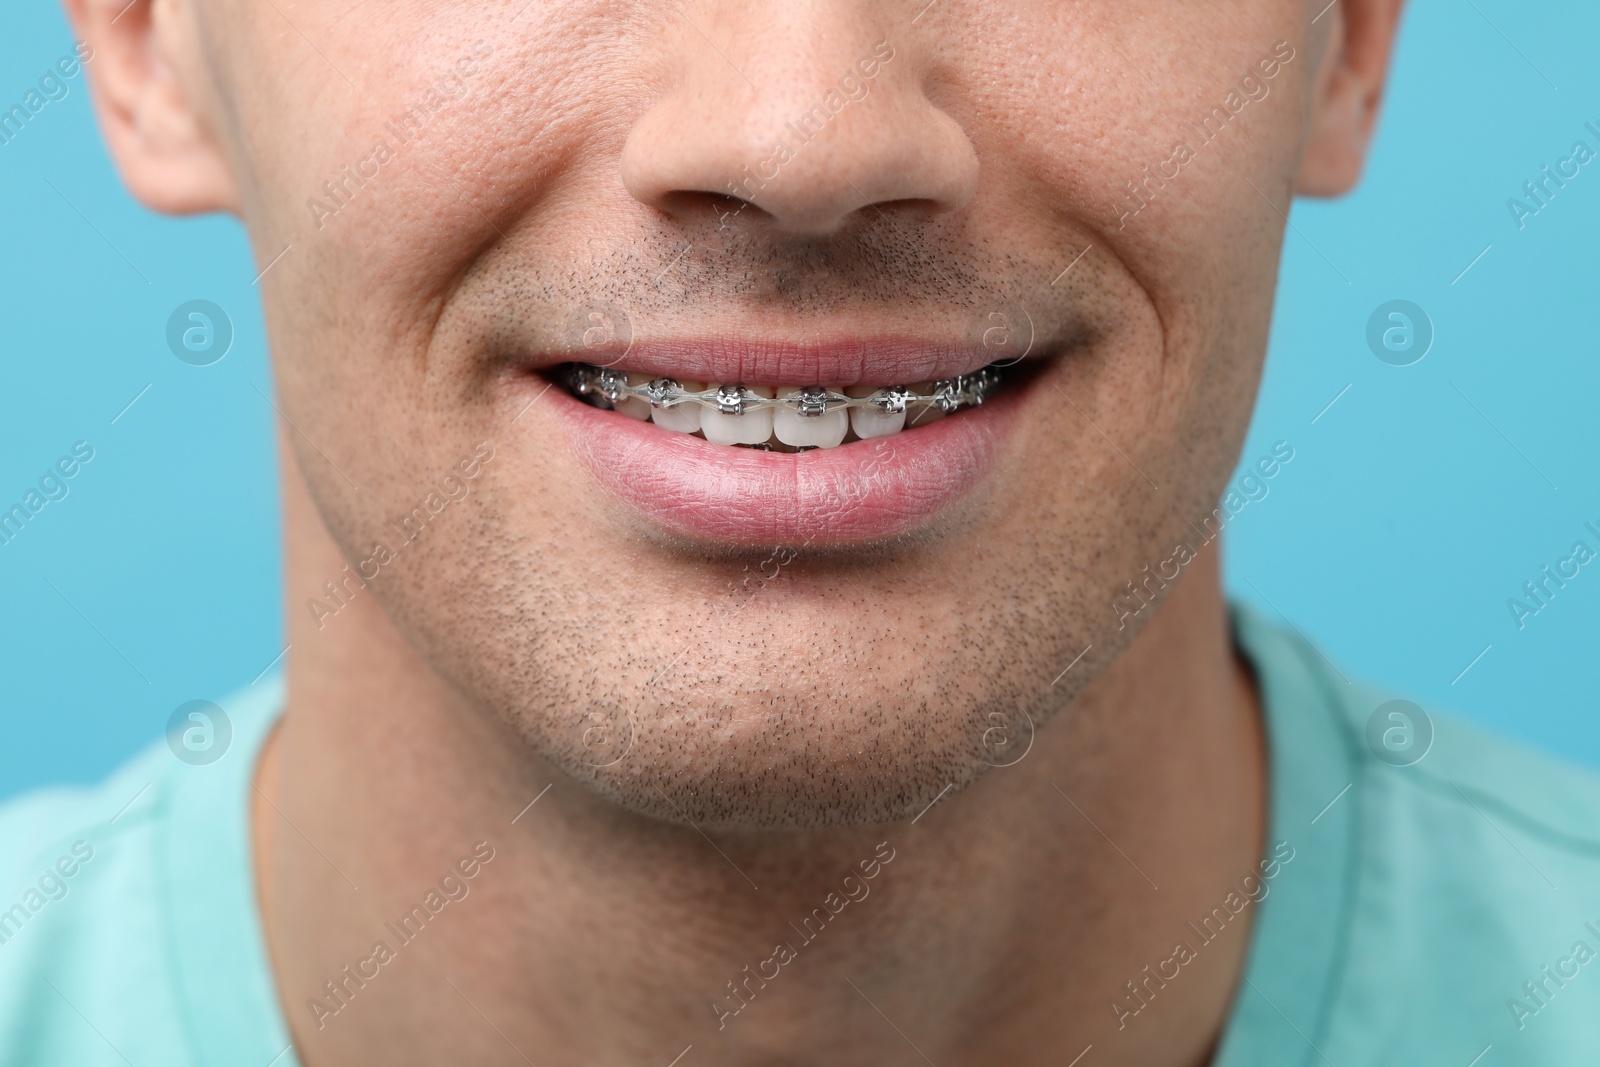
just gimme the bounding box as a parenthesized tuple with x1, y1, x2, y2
(530, 342, 1043, 547)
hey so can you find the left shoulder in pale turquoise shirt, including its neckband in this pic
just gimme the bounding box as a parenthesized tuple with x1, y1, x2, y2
(0, 683, 293, 1067)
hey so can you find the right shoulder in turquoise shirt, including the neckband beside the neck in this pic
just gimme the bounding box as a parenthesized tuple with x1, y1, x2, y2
(1238, 604, 1600, 1067)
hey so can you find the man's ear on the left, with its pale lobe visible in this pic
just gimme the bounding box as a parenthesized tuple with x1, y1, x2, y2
(62, 0, 238, 214)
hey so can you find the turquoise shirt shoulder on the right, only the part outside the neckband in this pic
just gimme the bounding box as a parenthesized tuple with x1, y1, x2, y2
(1349, 694, 1600, 1064)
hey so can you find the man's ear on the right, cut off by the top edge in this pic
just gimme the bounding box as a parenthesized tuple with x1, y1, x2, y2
(1296, 0, 1403, 197)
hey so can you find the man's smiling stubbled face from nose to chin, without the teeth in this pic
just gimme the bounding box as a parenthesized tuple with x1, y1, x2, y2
(178, 0, 1333, 827)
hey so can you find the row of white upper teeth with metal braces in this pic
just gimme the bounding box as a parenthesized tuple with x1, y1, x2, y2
(568, 363, 1000, 448)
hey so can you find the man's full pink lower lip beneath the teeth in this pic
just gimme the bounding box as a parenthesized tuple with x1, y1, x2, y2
(550, 377, 1018, 545)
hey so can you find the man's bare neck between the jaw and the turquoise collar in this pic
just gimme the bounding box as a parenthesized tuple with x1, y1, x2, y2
(253, 462, 1266, 1067)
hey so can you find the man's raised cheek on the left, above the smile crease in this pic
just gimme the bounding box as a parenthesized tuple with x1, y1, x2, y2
(234, 5, 611, 275)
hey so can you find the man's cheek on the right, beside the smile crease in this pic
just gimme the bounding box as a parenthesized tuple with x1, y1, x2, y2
(957, 2, 1312, 422)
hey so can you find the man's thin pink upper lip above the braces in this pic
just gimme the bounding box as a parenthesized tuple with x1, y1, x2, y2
(533, 336, 1016, 386)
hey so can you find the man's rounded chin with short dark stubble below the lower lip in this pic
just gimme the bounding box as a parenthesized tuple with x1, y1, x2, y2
(467, 574, 1070, 832)
